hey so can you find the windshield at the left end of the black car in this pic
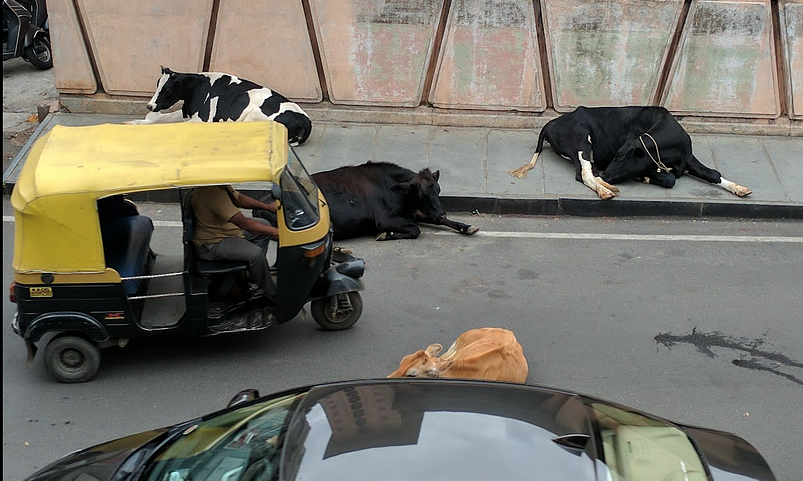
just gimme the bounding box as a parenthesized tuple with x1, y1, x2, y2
(140, 394, 304, 481)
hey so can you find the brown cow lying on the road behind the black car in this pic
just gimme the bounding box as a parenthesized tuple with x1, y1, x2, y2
(388, 327, 529, 382)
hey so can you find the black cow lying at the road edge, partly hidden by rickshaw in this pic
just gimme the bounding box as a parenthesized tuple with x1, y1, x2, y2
(253, 162, 479, 240)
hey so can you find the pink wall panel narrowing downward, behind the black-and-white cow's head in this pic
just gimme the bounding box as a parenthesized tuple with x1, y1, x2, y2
(77, 0, 212, 96)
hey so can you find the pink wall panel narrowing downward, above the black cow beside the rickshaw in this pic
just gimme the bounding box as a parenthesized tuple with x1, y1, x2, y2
(310, 0, 443, 107)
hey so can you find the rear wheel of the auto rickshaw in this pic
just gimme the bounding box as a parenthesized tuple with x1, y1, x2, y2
(44, 335, 100, 382)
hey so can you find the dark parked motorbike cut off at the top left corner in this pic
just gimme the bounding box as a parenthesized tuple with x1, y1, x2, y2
(3, 0, 53, 70)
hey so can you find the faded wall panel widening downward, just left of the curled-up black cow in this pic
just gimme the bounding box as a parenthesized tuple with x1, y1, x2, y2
(430, 0, 546, 112)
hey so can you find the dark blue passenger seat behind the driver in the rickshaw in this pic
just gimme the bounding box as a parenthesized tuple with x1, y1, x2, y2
(100, 215, 153, 296)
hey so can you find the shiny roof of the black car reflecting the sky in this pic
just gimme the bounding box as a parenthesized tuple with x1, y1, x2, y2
(283, 379, 596, 481)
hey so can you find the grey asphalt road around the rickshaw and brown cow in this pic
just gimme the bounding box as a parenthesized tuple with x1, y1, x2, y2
(2, 199, 803, 481)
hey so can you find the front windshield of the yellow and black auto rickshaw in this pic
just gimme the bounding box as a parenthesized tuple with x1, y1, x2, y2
(279, 148, 320, 230)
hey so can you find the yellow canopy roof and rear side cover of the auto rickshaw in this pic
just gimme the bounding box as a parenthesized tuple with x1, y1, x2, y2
(11, 121, 289, 274)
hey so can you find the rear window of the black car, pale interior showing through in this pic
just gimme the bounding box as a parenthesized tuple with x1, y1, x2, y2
(590, 403, 708, 481)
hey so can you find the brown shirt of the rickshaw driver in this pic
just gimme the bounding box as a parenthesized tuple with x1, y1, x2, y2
(192, 185, 243, 245)
